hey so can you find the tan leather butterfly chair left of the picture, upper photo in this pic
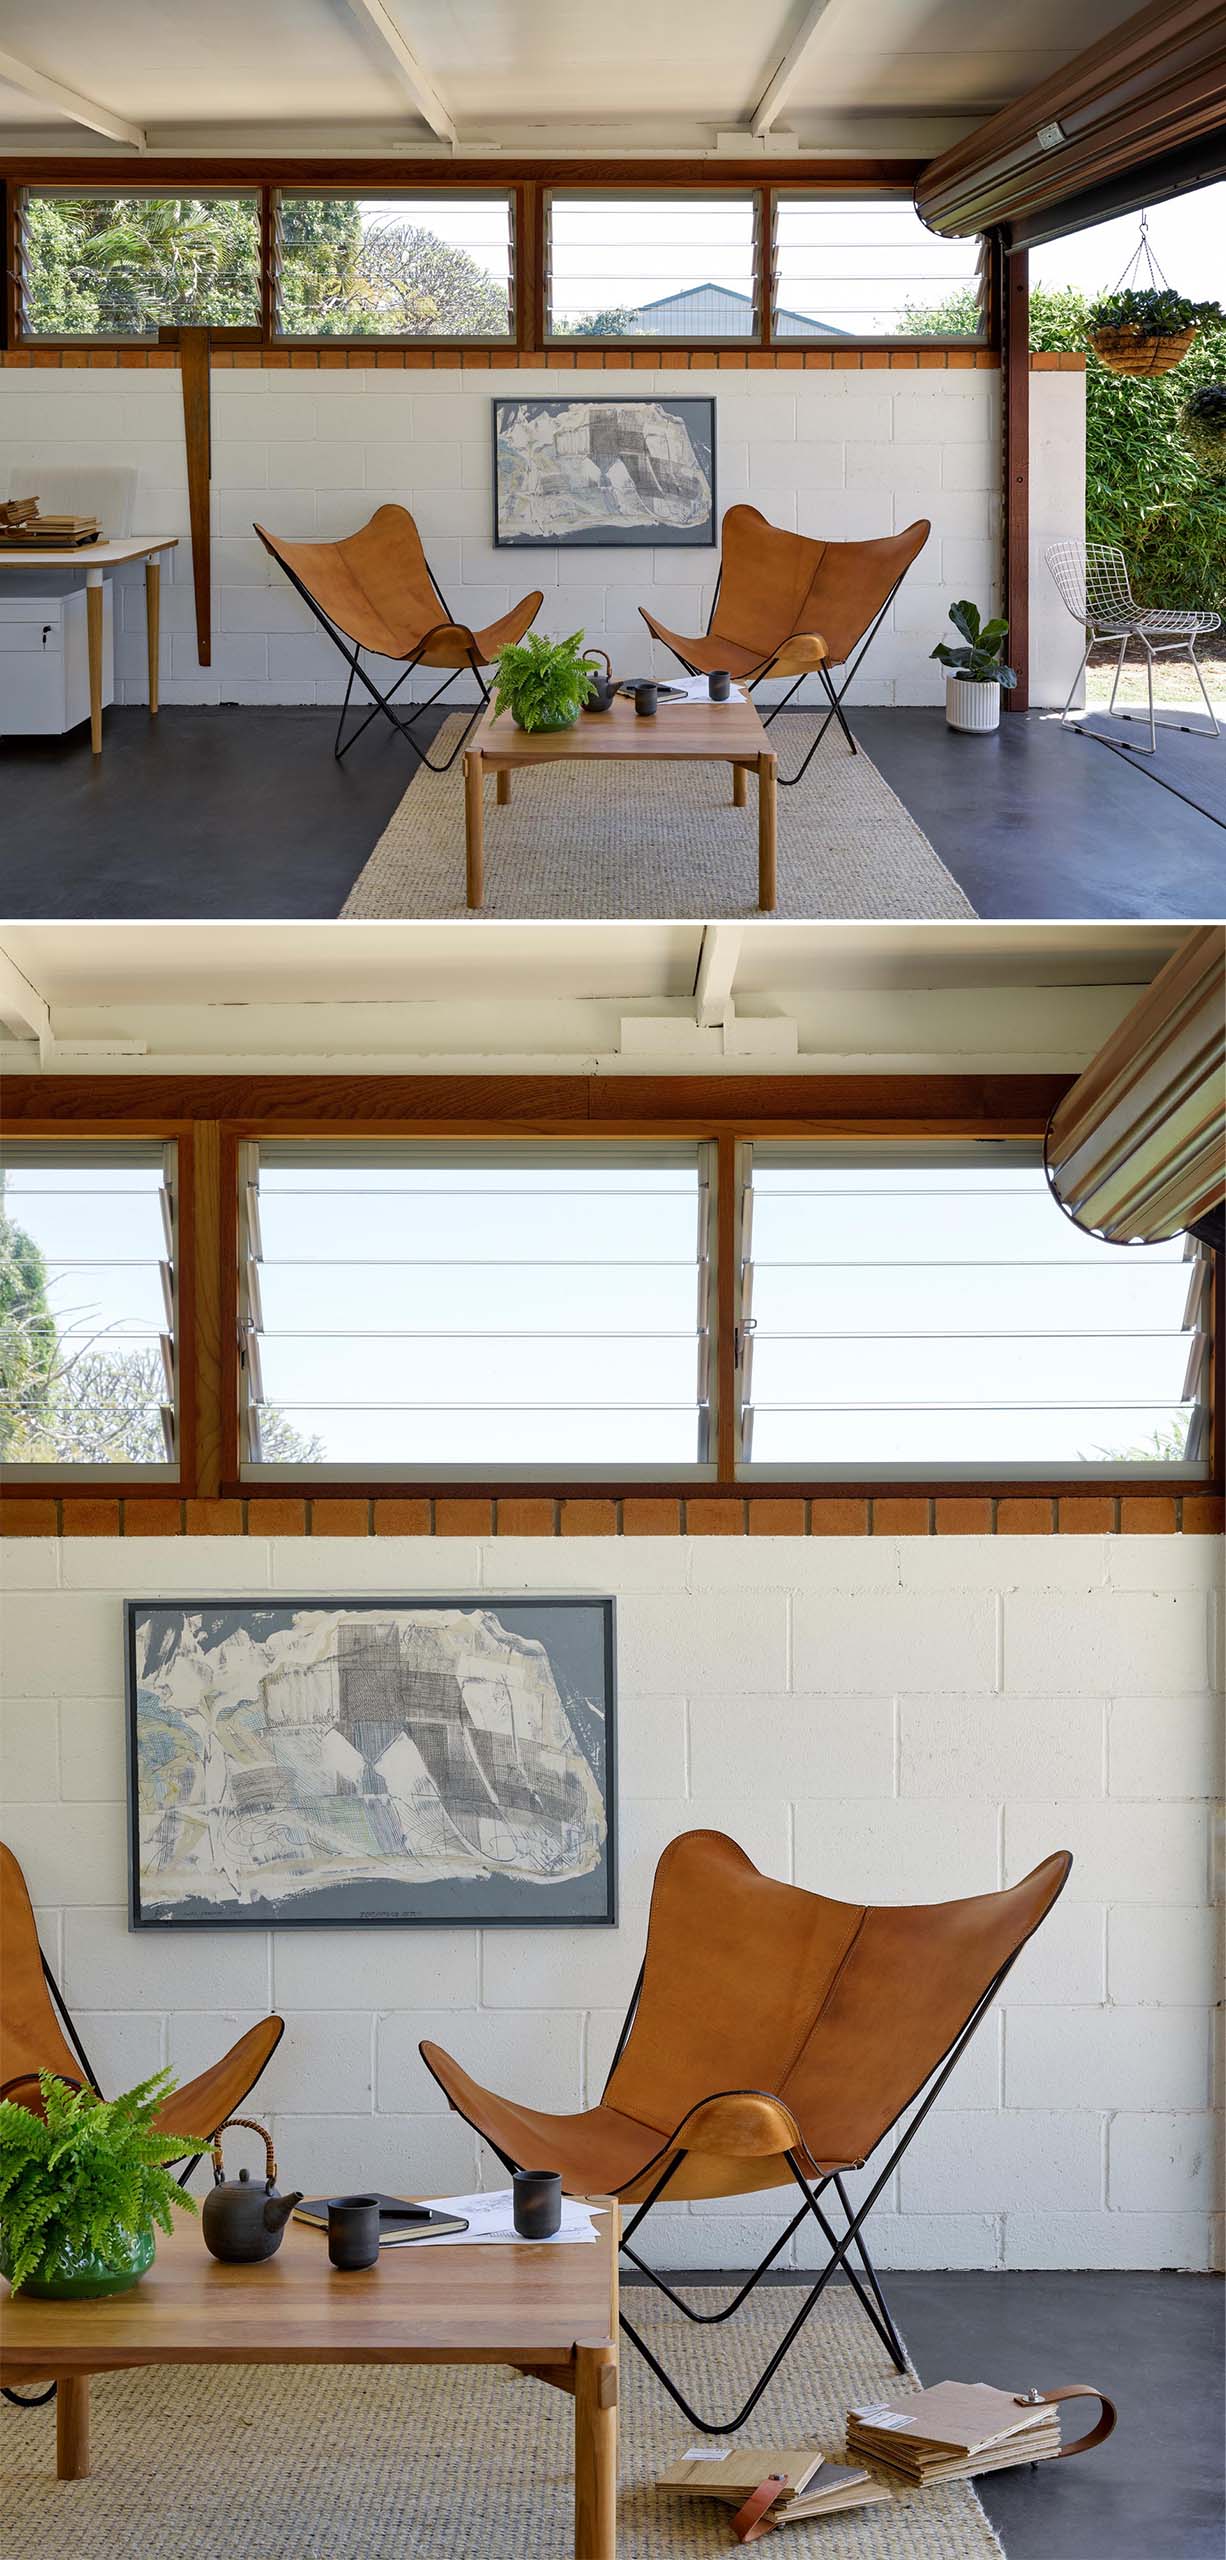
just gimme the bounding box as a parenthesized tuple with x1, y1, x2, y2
(256, 507, 545, 773)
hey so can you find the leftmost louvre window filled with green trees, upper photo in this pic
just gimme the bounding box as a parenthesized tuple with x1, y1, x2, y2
(18, 187, 261, 340)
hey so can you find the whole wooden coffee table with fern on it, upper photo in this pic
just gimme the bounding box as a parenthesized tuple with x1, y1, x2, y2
(463, 686, 778, 911)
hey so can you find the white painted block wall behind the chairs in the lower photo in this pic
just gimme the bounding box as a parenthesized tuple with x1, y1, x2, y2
(0, 1536, 1221, 2268)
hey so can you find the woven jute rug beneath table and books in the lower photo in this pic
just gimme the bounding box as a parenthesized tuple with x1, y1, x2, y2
(0, 2286, 1008, 2560)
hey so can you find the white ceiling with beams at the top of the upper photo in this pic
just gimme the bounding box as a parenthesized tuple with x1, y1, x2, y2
(0, 0, 1151, 159)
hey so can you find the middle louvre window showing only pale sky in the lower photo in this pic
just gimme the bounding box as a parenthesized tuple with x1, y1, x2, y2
(241, 1142, 709, 1477)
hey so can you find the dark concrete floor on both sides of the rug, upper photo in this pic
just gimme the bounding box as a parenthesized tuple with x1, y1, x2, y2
(0, 707, 1226, 919)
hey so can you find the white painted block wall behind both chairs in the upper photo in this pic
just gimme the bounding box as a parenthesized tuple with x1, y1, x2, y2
(0, 366, 1080, 704)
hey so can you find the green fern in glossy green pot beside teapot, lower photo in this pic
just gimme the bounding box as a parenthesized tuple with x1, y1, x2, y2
(0, 2071, 207, 2291)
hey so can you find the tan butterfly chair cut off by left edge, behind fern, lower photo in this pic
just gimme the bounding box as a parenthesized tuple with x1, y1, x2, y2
(0, 1841, 284, 2173)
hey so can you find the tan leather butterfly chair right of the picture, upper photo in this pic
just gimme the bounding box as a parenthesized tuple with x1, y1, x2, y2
(640, 507, 932, 783)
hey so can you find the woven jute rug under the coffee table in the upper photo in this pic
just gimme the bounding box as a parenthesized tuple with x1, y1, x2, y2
(343, 712, 975, 919)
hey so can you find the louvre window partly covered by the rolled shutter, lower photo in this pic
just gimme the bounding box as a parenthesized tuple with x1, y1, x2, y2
(740, 1142, 1211, 1477)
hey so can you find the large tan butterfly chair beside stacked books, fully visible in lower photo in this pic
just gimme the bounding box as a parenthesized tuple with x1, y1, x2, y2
(420, 1830, 1072, 2435)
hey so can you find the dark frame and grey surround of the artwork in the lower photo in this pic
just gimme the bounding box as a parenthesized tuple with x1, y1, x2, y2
(123, 1592, 617, 1930)
